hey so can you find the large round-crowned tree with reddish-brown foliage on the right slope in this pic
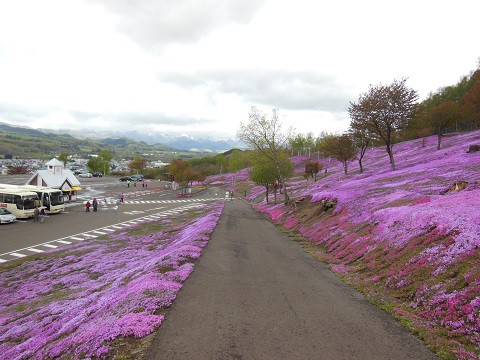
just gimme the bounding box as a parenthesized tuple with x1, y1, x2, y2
(348, 79, 418, 170)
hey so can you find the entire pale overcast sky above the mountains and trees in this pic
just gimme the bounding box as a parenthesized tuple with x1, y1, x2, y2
(0, 0, 480, 137)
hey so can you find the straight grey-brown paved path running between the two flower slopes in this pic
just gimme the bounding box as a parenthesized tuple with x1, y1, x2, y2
(145, 200, 436, 360)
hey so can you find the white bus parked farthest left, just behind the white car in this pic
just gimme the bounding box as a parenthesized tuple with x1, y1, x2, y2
(0, 188, 38, 219)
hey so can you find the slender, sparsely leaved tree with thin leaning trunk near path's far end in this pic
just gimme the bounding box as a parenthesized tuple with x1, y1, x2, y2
(237, 106, 292, 203)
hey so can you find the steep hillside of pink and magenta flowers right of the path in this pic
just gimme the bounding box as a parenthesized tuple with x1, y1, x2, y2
(209, 131, 480, 359)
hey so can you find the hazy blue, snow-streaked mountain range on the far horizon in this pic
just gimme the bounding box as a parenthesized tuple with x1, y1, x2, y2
(42, 129, 246, 152)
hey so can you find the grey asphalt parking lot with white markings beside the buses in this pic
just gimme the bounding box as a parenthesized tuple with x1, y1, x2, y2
(0, 175, 225, 263)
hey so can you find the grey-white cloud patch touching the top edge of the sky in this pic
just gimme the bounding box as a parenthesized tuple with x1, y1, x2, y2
(85, 0, 265, 50)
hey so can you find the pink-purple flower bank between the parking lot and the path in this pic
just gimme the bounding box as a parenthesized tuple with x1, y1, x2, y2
(0, 203, 223, 359)
